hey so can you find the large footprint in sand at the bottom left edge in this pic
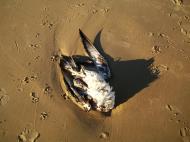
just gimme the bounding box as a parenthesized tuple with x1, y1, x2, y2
(18, 128, 40, 142)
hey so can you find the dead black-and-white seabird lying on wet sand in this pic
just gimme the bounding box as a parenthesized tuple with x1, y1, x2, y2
(59, 29, 115, 112)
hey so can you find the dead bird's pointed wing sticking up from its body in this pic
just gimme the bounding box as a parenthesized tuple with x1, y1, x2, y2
(79, 29, 111, 80)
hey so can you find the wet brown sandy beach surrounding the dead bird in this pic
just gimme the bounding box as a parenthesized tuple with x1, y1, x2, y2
(0, 0, 190, 142)
